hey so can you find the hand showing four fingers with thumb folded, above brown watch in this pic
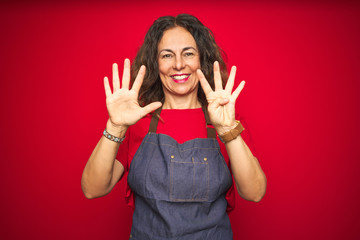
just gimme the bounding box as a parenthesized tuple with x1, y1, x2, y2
(197, 61, 245, 135)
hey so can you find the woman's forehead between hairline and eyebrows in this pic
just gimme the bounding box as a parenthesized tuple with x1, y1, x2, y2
(158, 27, 197, 51)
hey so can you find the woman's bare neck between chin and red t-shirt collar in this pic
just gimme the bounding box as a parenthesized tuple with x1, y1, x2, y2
(163, 94, 201, 109)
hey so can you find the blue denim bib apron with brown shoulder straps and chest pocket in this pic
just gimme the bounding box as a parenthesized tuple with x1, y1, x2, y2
(128, 107, 232, 240)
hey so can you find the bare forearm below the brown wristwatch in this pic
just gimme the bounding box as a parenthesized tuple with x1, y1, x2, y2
(225, 135, 266, 202)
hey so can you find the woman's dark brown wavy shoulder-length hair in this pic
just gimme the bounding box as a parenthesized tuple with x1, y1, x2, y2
(131, 14, 228, 106)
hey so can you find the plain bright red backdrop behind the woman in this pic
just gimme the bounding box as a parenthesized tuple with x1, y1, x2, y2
(0, 0, 360, 239)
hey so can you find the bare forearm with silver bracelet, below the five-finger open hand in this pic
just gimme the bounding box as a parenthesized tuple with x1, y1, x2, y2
(81, 122, 127, 198)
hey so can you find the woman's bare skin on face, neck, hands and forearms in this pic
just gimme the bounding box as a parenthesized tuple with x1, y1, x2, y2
(81, 27, 266, 202)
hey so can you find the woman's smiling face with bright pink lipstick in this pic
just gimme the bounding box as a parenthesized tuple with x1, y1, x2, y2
(158, 27, 200, 97)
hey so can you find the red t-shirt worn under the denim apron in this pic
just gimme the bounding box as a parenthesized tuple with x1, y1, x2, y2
(117, 108, 255, 212)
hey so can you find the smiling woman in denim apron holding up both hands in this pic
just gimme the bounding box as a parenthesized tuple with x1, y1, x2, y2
(82, 14, 266, 239)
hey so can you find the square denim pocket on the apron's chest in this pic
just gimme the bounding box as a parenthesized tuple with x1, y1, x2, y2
(170, 156, 209, 202)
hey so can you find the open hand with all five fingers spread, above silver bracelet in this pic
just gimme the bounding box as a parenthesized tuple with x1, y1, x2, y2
(104, 59, 161, 132)
